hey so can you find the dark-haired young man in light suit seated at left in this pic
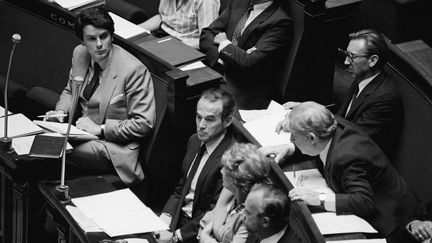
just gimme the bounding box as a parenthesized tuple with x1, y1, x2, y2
(46, 8, 156, 184)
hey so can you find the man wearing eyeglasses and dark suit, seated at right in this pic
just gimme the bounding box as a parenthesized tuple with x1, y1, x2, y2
(278, 29, 402, 160)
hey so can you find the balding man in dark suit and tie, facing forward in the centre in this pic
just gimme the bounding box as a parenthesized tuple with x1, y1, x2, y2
(156, 89, 235, 242)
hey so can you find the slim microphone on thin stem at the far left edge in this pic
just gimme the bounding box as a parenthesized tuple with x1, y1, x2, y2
(0, 34, 21, 153)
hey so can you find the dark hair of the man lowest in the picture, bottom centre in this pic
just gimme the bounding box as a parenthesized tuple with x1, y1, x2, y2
(250, 183, 291, 230)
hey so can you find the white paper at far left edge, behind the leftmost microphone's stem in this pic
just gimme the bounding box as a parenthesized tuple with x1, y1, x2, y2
(0, 113, 44, 138)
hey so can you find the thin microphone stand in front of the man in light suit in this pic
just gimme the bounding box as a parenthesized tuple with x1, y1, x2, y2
(56, 76, 84, 204)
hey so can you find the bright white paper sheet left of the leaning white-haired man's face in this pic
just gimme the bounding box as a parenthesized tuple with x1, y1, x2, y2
(243, 112, 291, 147)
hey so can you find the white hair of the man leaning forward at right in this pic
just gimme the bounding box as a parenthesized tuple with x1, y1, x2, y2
(288, 101, 337, 139)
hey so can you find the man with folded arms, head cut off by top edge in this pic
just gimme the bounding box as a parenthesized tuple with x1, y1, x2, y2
(200, 0, 292, 109)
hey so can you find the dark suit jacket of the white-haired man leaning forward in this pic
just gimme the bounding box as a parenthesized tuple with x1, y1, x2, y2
(324, 117, 417, 236)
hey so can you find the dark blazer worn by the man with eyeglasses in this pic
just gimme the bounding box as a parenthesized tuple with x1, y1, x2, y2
(337, 72, 403, 159)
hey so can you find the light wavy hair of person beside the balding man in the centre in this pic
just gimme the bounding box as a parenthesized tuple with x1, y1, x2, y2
(221, 143, 270, 196)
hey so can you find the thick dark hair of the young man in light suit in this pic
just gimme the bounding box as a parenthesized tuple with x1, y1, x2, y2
(75, 7, 114, 40)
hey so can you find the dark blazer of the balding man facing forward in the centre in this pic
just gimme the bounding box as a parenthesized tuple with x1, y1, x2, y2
(162, 132, 234, 241)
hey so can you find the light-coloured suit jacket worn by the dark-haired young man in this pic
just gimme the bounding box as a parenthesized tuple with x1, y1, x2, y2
(56, 45, 156, 184)
